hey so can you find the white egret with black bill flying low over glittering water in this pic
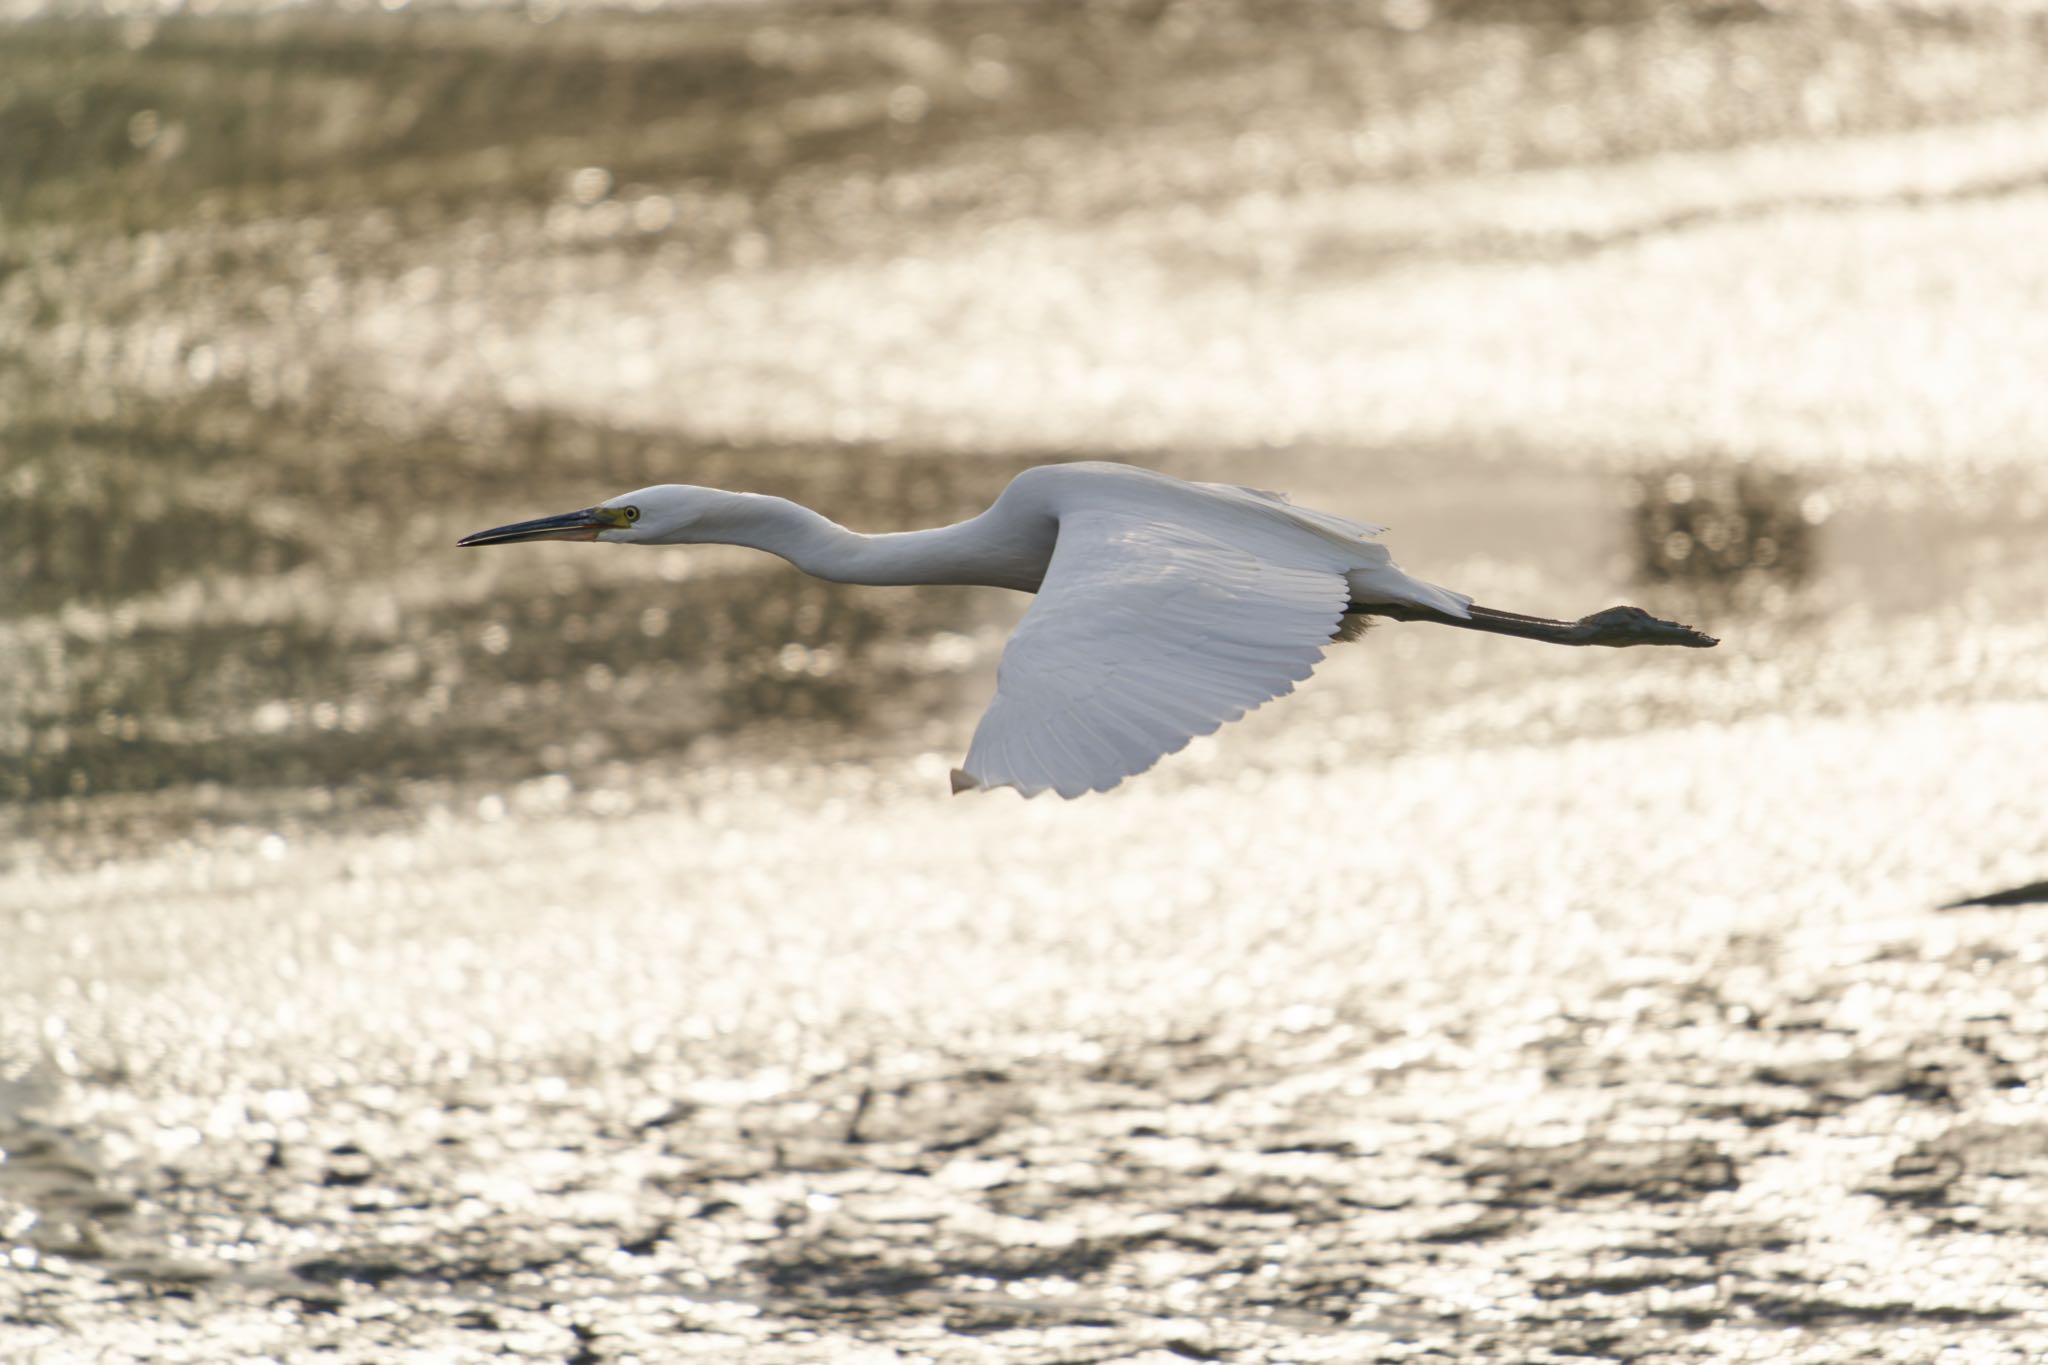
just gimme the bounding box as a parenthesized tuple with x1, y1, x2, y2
(461, 463, 1716, 796)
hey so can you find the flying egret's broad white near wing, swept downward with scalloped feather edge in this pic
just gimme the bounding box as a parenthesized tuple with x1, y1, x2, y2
(952, 512, 1350, 796)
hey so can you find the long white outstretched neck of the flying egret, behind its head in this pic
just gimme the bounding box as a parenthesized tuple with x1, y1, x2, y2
(686, 493, 1051, 591)
